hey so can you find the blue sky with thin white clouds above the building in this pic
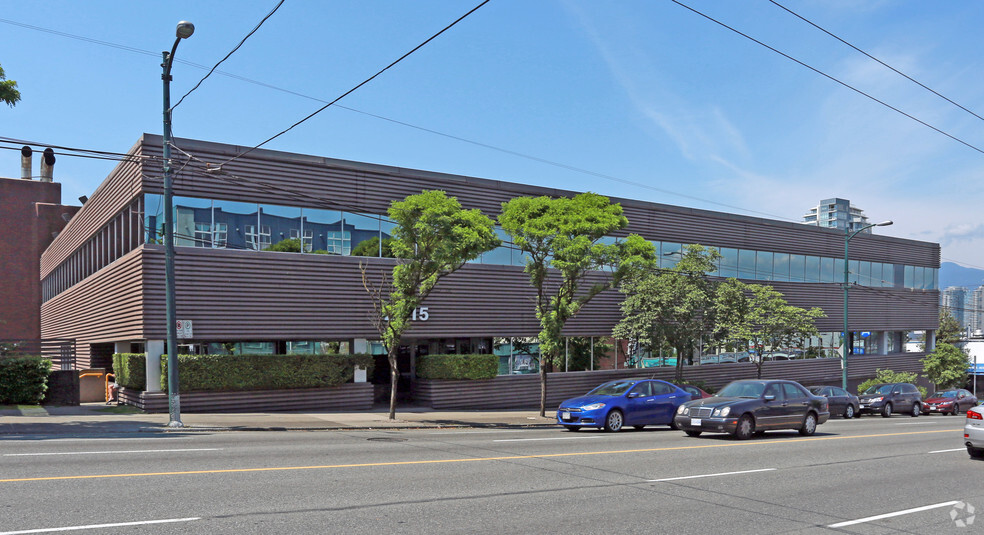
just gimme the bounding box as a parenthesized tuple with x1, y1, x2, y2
(0, 0, 984, 267)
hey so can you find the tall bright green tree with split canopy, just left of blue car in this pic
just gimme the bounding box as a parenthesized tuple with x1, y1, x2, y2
(499, 193, 654, 416)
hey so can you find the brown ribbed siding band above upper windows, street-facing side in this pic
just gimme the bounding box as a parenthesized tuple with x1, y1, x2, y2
(143, 134, 940, 268)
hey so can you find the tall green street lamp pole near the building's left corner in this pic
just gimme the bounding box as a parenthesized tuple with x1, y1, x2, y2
(161, 20, 195, 427)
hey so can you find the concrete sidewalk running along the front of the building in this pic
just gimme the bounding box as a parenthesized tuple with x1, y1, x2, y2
(0, 403, 556, 439)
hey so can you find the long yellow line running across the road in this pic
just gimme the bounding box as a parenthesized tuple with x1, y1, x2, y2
(0, 429, 959, 483)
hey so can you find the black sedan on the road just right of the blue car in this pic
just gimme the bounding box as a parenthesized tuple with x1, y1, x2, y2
(674, 380, 830, 440)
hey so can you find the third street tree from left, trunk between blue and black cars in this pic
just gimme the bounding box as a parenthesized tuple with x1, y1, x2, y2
(612, 245, 721, 381)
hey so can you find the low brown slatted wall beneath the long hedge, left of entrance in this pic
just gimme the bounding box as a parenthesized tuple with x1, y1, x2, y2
(119, 383, 373, 413)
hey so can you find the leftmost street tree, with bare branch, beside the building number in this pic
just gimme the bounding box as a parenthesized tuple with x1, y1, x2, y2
(360, 190, 500, 420)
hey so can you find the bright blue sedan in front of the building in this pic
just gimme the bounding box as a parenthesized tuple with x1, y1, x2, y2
(557, 379, 692, 432)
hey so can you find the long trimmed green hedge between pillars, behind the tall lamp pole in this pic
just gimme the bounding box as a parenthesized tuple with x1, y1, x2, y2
(161, 355, 374, 392)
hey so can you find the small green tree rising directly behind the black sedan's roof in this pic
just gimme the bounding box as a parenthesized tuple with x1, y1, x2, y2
(715, 279, 825, 378)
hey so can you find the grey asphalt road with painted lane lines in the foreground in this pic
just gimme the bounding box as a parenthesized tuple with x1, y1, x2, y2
(0, 416, 984, 535)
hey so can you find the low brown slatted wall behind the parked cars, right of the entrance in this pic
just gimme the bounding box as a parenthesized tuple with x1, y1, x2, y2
(413, 353, 925, 411)
